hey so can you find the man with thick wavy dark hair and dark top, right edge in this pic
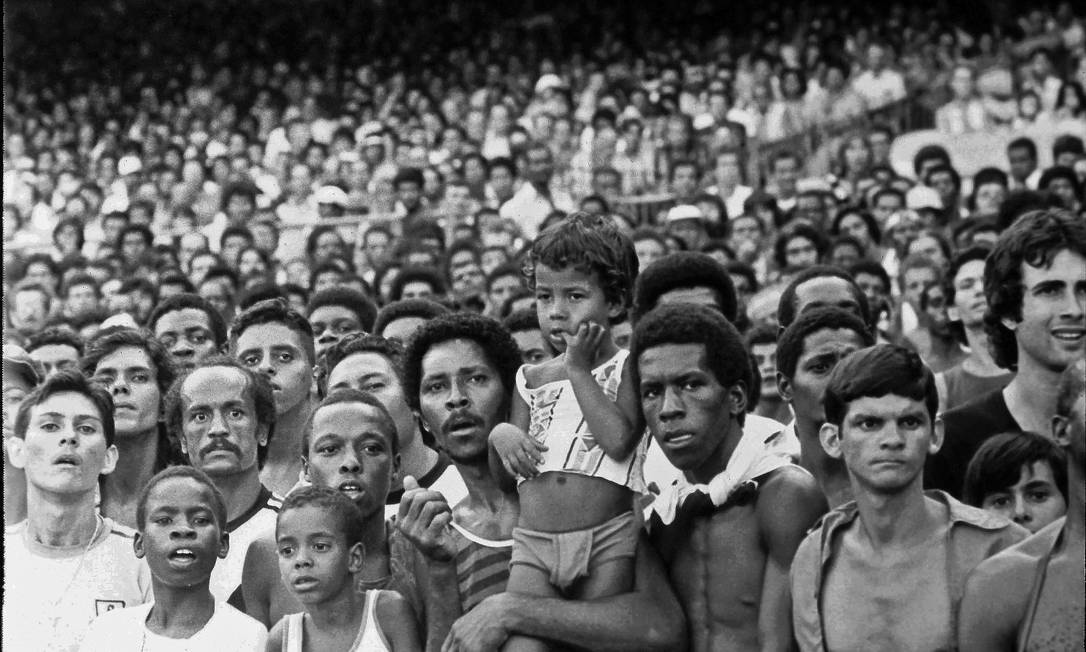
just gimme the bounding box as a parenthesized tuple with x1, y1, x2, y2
(924, 210, 1086, 497)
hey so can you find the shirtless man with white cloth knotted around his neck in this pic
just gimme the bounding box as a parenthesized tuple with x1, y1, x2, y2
(630, 304, 825, 652)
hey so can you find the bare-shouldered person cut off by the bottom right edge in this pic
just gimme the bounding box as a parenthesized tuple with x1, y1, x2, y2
(958, 360, 1086, 652)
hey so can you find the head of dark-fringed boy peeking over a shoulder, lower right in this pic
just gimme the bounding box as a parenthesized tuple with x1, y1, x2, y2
(962, 432, 1068, 532)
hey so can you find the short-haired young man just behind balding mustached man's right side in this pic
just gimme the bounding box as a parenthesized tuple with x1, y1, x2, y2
(230, 299, 316, 496)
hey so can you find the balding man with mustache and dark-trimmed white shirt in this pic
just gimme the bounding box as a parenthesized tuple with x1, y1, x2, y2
(166, 355, 282, 609)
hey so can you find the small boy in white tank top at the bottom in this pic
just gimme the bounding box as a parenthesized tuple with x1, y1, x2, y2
(267, 486, 421, 652)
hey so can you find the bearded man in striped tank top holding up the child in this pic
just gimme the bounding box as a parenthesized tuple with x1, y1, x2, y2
(397, 313, 683, 650)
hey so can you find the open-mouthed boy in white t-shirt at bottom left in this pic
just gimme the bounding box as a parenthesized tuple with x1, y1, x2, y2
(79, 466, 267, 652)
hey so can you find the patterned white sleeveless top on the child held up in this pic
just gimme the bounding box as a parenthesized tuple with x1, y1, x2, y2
(517, 349, 648, 493)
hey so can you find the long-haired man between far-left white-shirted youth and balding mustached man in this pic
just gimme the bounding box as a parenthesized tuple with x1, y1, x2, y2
(79, 327, 184, 527)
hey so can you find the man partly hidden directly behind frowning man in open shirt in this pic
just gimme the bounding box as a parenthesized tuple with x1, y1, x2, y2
(776, 308, 875, 507)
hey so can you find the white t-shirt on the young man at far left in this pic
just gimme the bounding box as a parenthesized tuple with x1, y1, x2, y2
(3, 517, 151, 652)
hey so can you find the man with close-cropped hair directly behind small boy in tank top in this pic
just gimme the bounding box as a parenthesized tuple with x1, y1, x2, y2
(241, 389, 422, 627)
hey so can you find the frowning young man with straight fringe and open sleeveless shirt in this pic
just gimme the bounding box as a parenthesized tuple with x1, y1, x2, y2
(792, 344, 1028, 651)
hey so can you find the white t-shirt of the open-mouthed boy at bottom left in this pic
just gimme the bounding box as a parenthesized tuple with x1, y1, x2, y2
(79, 602, 268, 652)
